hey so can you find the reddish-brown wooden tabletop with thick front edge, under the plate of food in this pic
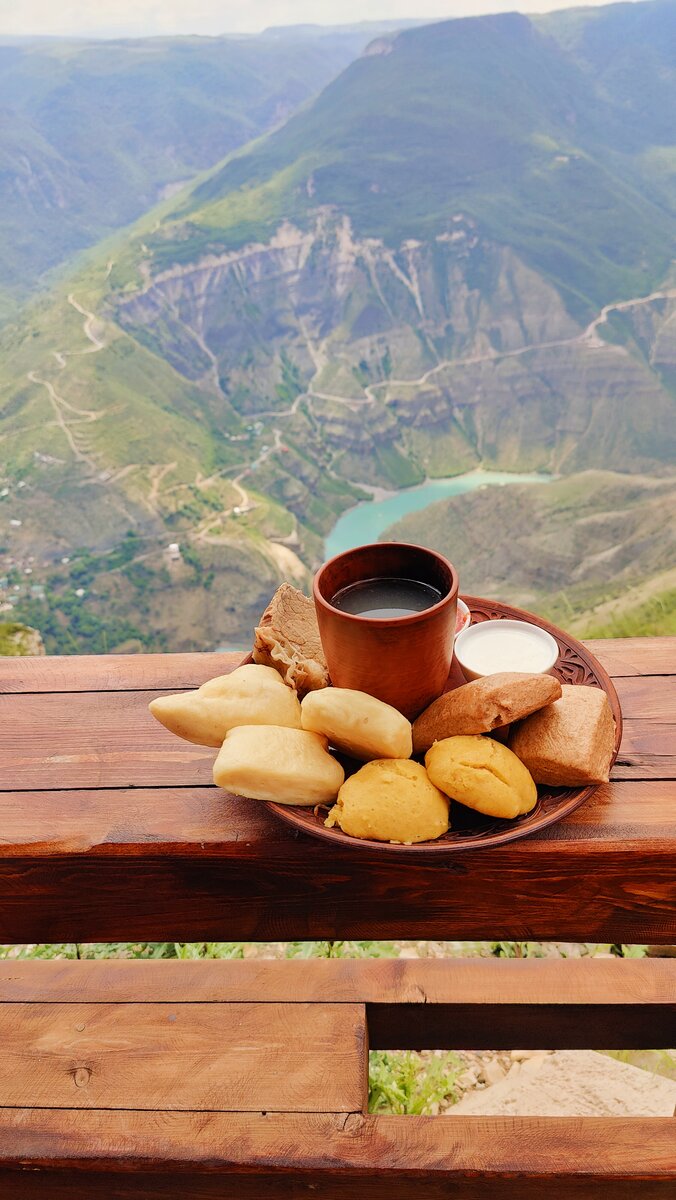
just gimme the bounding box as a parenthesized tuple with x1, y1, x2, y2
(0, 638, 676, 944)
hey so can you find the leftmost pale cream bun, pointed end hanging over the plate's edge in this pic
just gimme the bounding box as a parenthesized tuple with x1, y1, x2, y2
(148, 662, 300, 746)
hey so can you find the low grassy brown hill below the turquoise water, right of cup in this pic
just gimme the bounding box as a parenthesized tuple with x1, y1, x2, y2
(385, 470, 676, 636)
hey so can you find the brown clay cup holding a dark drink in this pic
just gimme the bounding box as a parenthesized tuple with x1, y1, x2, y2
(313, 541, 457, 720)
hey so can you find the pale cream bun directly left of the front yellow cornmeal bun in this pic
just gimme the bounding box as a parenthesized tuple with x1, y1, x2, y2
(214, 725, 345, 806)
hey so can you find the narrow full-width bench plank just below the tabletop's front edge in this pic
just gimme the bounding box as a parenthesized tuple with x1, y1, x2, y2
(0, 958, 676, 1021)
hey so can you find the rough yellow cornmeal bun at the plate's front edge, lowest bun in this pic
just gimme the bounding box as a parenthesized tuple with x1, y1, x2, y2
(324, 758, 448, 845)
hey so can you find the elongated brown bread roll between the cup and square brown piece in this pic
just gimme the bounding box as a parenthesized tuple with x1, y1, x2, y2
(413, 671, 561, 754)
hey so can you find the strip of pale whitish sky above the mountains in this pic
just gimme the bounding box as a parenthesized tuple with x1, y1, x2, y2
(0, 0, 643, 37)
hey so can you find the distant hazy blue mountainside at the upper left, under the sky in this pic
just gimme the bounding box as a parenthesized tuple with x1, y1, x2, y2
(0, 29, 381, 316)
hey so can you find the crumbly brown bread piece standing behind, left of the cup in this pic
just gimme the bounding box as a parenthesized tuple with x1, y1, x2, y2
(253, 583, 329, 697)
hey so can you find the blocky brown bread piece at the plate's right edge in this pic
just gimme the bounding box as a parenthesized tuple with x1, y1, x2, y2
(509, 684, 615, 787)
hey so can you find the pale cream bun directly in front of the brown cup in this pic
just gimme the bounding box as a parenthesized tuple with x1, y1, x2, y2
(300, 688, 412, 762)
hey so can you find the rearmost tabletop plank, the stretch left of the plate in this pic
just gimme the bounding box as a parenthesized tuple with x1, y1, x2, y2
(0, 650, 247, 694)
